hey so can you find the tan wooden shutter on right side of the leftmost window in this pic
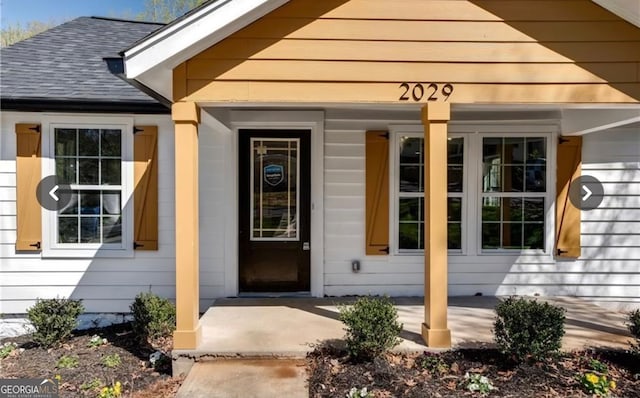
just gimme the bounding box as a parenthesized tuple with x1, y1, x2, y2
(133, 126, 158, 250)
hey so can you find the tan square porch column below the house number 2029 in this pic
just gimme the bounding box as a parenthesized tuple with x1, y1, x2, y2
(422, 102, 451, 348)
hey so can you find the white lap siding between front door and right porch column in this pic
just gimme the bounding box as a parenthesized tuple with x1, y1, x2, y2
(324, 110, 423, 296)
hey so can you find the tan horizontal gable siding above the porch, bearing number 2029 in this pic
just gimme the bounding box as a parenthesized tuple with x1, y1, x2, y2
(174, 0, 640, 103)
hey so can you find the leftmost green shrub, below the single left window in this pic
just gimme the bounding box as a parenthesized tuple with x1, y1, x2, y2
(27, 298, 84, 348)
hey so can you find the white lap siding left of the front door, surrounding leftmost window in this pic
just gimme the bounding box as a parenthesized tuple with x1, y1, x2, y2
(0, 113, 224, 313)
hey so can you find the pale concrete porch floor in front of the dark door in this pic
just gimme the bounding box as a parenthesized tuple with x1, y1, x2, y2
(173, 297, 631, 362)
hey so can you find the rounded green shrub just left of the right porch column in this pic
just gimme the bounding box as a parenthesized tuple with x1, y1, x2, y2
(339, 296, 402, 361)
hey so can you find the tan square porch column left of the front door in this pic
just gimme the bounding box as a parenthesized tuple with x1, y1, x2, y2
(171, 102, 201, 350)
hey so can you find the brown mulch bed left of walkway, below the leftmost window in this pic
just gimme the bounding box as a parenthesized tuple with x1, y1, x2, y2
(0, 324, 180, 397)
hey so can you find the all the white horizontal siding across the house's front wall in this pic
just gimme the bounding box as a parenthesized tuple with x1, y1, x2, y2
(0, 109, 640, 313)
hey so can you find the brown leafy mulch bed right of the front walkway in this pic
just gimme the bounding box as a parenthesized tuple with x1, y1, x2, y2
(308, 345, 640, 398)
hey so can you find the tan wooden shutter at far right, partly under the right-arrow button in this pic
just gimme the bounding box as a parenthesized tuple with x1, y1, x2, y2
(556, 137, 582, 258)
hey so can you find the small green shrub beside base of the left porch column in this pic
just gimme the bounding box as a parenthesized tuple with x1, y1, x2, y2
(130, 292, 176, 341)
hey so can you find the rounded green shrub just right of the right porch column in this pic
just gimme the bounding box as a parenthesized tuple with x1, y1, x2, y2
(493, 297, 565, 362)
